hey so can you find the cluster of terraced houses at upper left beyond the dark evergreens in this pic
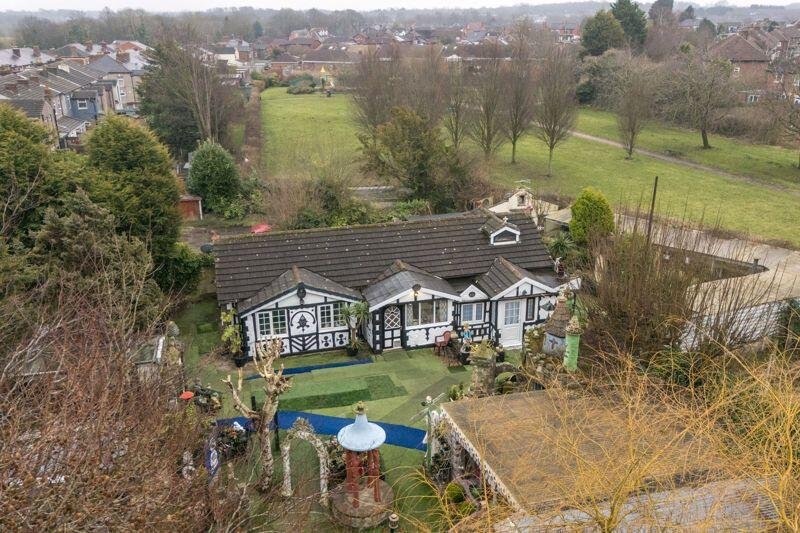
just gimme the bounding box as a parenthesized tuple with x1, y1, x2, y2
(0, 41, 147, 148)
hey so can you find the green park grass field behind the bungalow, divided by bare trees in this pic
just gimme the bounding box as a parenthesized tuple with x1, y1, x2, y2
(262, 88, 800, 246)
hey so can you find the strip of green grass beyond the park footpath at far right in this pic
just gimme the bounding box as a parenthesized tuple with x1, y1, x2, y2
(575, 108, 800, 191)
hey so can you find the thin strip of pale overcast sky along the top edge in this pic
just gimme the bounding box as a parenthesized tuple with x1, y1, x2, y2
(0, 0, 796, 11)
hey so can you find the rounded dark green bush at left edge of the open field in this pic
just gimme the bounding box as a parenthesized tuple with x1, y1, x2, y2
(187, 141, 241, 213)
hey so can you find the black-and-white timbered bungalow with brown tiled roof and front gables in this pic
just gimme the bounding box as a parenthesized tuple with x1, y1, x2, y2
(214, 209, 565, 356)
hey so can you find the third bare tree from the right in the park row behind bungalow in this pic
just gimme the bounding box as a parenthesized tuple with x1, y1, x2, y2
(469, 45, 506, 159)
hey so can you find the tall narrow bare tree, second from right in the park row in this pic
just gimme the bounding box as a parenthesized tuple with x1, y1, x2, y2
(503, 19, 536, 163)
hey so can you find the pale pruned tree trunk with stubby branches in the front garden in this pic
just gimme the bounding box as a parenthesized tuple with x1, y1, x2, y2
(222, 339, 292, 490)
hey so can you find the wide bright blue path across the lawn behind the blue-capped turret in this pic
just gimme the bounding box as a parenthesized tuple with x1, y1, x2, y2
(216, 411, 425, 451)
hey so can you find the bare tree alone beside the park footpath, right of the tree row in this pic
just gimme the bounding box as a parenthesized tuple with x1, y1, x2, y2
(612, 55, 658, 159)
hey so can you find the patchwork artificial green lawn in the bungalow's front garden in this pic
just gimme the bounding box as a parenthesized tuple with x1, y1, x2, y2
(175, 294, 462, 531)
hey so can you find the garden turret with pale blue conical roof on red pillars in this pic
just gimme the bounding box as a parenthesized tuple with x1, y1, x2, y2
(331, 402, 394, 529)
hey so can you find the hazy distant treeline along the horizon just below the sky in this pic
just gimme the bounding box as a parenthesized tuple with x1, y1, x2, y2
(0, 1, 800, 48)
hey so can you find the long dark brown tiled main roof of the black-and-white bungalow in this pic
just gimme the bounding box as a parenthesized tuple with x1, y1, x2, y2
(214, 211, 553, 303)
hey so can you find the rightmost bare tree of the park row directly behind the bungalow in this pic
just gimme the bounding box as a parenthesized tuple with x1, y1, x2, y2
(533, 46, 578, 176)
